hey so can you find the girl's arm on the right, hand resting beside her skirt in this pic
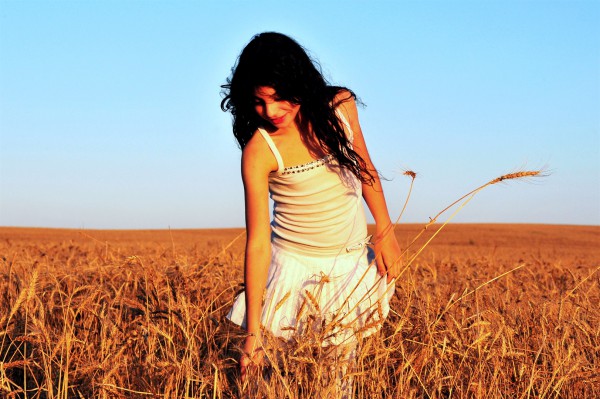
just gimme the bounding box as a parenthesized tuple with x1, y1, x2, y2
(336, 92, 402, 283)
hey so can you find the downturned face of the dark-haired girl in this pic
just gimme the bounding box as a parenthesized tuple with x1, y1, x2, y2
(254, 86, 300, 129)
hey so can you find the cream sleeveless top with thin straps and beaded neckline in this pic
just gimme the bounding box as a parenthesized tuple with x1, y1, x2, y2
(258, 112, 367, 256)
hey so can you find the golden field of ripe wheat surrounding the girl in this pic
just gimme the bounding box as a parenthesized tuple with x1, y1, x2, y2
(0, 224, 600, 399)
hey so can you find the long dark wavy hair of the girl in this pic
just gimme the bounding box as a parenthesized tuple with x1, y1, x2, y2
(221, 32, 373, 183)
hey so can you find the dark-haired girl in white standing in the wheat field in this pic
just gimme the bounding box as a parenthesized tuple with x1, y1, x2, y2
(221, 32, 400, 396)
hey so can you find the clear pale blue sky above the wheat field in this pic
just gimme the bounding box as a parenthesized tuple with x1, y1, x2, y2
(0, 0, 600, 229)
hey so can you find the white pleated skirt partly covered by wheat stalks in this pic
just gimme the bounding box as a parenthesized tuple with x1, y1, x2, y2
(227, 246, 395, 345)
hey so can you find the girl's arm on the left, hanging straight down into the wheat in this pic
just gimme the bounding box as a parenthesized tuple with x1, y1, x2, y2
(240, 137, 276, 376)
